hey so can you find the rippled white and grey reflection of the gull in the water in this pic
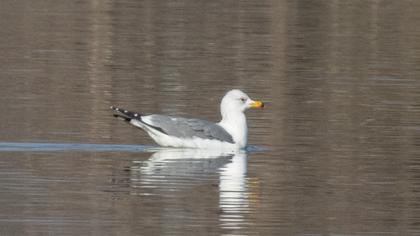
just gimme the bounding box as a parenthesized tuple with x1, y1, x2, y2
(130, 149, 251, 229)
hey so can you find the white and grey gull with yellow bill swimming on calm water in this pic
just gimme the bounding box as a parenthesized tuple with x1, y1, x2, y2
(111, 89, 264, 150)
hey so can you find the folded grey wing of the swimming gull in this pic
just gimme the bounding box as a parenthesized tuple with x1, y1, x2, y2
(149, 115, 234, 143)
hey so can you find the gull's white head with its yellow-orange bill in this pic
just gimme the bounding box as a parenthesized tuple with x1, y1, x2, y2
(220, 89, 264, 117)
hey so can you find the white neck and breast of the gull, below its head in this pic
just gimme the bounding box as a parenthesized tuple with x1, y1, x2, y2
(219, 111, 248, 148)
